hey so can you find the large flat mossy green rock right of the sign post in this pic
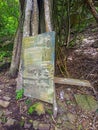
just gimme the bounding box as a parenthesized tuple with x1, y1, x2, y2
(75, 94, 98, 112)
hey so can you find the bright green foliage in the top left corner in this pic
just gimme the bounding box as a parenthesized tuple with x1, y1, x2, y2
(0, 0, 19, 36)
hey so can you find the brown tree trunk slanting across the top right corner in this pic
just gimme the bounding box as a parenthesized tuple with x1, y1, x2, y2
(86, 0, 98, 23)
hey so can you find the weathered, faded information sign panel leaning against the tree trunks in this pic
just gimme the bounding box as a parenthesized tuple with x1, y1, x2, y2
(22, 32, 55, 103)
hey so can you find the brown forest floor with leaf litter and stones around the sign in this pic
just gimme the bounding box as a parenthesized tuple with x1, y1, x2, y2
(0, 25, 98, 130)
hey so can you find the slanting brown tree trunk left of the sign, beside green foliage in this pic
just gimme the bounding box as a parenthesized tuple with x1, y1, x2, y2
(9, 1, 24, 77)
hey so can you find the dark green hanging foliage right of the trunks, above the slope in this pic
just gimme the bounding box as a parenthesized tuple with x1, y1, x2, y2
(53, 0, 94, 46)
